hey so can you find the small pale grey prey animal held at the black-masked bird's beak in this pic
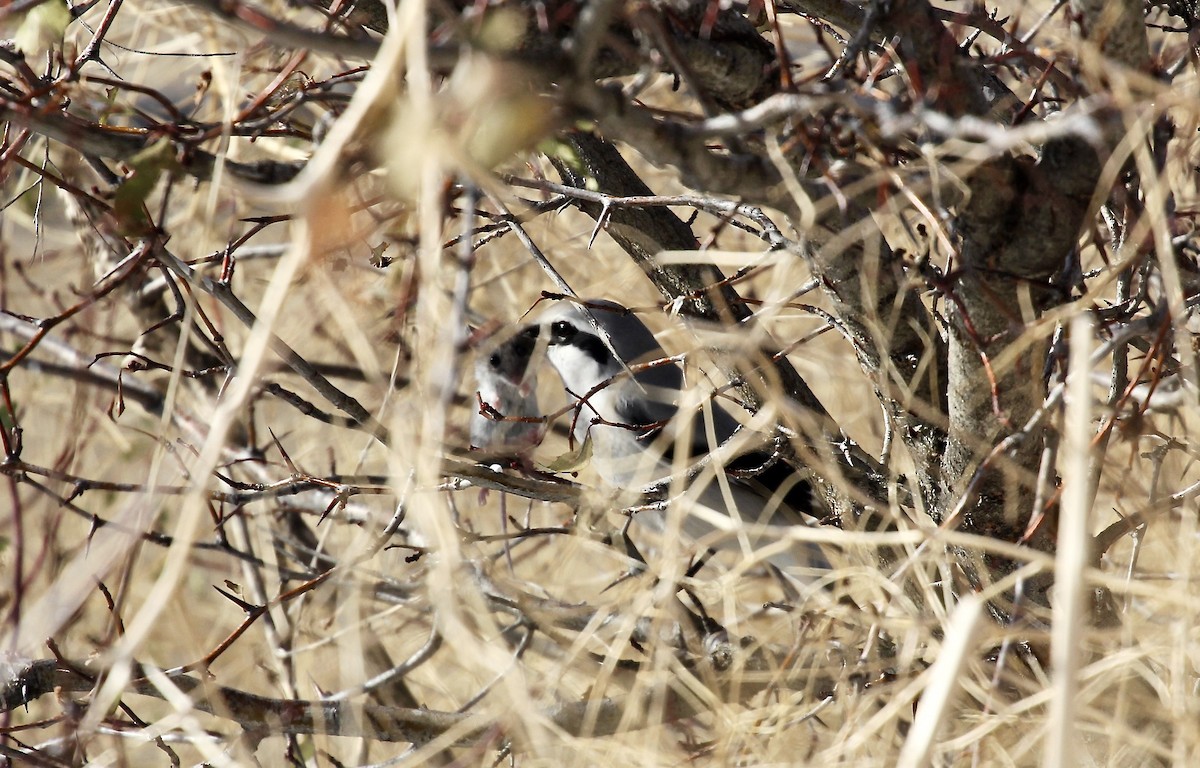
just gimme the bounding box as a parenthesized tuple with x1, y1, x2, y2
(470, 324, 545, 456)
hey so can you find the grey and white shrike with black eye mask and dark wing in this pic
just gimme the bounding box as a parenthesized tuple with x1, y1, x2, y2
(517, 299, 829, 571)
